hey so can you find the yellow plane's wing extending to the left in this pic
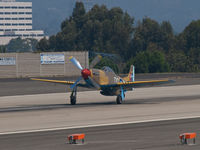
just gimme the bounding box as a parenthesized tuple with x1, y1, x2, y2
(31, 78, 88, 87)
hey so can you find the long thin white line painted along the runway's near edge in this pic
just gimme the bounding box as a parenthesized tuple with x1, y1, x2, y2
(0, 116, 200, 135)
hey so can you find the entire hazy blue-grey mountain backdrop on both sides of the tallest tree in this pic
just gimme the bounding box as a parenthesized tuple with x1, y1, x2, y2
(17, 0, 200, 35)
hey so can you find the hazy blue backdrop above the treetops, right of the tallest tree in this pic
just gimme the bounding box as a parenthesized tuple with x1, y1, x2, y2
(94, 0, 200, 32)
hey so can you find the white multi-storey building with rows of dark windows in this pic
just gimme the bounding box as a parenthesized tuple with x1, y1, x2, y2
(0, 0, 44, 45)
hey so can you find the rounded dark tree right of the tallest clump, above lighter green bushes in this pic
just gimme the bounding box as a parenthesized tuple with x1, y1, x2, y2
(129, 17, 175, 58)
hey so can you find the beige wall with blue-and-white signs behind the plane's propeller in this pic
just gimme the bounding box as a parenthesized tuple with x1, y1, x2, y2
(0, 51, 89, 78)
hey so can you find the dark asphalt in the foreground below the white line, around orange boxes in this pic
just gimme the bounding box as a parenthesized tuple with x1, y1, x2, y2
(0, 119, 200, 150)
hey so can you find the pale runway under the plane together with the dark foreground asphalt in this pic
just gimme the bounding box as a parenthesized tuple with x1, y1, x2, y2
(0, 76, 200, 150)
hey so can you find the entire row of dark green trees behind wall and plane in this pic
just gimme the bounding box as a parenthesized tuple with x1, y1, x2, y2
(35, 2, 200, 73)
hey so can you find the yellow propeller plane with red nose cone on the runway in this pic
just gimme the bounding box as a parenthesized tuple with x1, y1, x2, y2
(32, 55, 172, 105)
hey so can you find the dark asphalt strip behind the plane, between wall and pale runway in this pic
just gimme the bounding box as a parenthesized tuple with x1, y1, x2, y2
(0, 73, 200, 96)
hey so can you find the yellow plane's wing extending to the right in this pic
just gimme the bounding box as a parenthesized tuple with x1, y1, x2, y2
(101, 80, 174, 89)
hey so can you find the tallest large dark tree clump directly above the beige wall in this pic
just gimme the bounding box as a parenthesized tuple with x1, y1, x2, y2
(38, 2, 134, 59)
